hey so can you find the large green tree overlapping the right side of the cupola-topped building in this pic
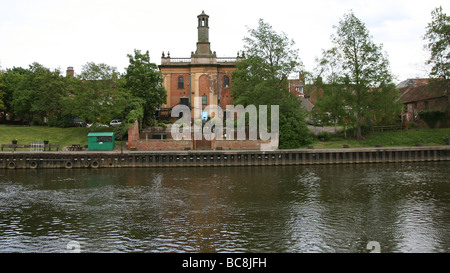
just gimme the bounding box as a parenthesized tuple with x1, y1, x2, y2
(232, 19, 311, 149)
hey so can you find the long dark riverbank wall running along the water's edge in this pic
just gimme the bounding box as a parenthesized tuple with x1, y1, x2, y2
(0, 145, 450, 169)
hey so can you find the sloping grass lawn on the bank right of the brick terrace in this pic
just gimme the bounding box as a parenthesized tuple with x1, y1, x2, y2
(302, 128, 450, 149)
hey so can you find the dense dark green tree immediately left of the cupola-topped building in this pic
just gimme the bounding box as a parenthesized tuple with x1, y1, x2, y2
(124, 50, 167, 124)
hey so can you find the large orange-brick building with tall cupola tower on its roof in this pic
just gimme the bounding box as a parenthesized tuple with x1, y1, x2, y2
(159, 12, 242, 119)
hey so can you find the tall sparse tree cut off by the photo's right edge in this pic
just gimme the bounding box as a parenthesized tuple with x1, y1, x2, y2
(424, 6, 450, 102)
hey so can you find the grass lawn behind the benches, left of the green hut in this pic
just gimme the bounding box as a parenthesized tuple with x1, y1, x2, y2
(0, 125, 120, 150)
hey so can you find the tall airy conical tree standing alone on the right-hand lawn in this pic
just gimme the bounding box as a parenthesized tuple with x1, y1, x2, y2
(329, 12, 400, 139)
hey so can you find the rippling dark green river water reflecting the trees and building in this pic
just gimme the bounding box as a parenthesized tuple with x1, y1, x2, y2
(0, 162, 450, 253)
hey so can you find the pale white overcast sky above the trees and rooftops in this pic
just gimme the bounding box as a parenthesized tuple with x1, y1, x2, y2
(0, 0, 450, 81)
